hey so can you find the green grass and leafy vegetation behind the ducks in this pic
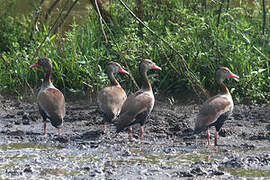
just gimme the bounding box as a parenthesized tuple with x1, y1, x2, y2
(0, 0, 270, 103)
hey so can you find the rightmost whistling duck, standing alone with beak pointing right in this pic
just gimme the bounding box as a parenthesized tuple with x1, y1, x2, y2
(194, 67, 239, 146)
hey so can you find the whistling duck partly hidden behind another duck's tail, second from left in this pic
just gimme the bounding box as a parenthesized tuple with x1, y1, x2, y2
(97, 62, 128, 132)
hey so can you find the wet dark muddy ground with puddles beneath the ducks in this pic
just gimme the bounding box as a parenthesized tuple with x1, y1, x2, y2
(0, 97, 270, 179)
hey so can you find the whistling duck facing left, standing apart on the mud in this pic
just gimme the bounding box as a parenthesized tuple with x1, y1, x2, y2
(30, 57, 65, 136)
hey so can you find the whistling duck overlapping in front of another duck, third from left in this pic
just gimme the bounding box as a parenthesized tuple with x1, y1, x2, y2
(116, 59, 161, 140)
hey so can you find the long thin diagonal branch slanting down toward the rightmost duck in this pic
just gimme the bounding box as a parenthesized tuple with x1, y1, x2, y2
(119, 0, 209, 98)
